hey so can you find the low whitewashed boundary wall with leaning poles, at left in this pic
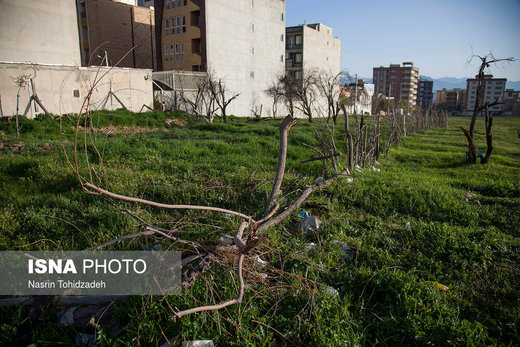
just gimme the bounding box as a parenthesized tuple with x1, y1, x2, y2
(0, 62, 153, 117)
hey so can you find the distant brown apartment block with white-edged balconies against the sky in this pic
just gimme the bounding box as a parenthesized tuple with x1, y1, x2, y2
(373, 62, 419, 105)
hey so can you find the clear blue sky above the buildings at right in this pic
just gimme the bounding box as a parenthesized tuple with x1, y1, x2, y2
(286, 0, 520, 81)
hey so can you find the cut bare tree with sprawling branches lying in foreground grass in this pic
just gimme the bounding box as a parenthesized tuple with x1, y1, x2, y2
(74, 113, 349, 319)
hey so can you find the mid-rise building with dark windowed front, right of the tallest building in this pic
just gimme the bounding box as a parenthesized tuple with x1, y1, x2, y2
(285, 23, 341, 79)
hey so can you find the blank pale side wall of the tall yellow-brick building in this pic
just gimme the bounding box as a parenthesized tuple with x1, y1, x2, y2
(205, 0, 285, 116)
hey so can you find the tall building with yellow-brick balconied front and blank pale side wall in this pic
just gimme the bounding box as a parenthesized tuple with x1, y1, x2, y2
(155, 0, 285, 116)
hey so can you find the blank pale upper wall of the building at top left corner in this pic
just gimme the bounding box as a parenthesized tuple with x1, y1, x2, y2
(0, 0, 81, 65)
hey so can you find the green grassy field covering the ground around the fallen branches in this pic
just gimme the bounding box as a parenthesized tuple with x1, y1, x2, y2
(0, 112, 520, 346)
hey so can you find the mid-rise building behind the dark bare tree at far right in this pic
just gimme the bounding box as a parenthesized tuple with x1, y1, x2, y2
(465, 75, 507, 112)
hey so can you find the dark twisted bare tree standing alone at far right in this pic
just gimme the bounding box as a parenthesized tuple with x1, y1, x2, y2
(461, 53, 515, 164)
